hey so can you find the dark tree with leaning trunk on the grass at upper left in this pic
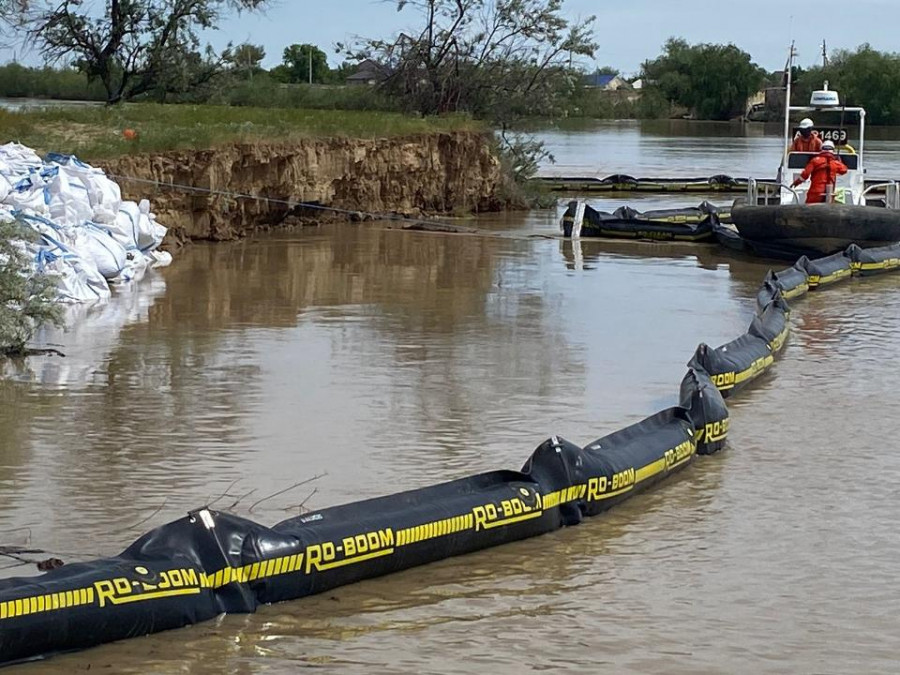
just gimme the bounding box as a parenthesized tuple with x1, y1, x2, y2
(22, 0, 266, 103)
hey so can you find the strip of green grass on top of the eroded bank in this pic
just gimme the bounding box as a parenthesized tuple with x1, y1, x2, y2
(0, 103, 485, 161)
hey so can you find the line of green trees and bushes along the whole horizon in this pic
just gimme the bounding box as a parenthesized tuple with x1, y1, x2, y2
(0, 0, 900, 128)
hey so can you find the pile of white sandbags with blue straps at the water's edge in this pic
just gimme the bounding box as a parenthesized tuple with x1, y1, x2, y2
(0, 143, 172, 302)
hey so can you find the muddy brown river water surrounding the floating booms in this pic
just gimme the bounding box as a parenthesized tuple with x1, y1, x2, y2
(0, 124, 900, 674)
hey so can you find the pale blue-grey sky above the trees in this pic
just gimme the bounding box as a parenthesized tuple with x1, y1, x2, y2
(0, 0, 900, 74)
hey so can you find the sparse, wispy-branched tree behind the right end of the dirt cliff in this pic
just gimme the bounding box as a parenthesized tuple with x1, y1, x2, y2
(348, 0, 596, 124)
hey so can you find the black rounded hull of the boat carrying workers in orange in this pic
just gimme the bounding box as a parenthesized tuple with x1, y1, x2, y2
(731, 204, 900, 260)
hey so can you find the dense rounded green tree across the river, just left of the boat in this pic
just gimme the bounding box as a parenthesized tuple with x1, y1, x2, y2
(643, 38, 766, 120)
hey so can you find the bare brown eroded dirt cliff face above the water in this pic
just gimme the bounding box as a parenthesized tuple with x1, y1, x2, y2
(97, 132, 503, 244)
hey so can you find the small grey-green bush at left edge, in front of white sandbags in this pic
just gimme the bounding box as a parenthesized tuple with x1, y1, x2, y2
(0, 219, 62, 355)
